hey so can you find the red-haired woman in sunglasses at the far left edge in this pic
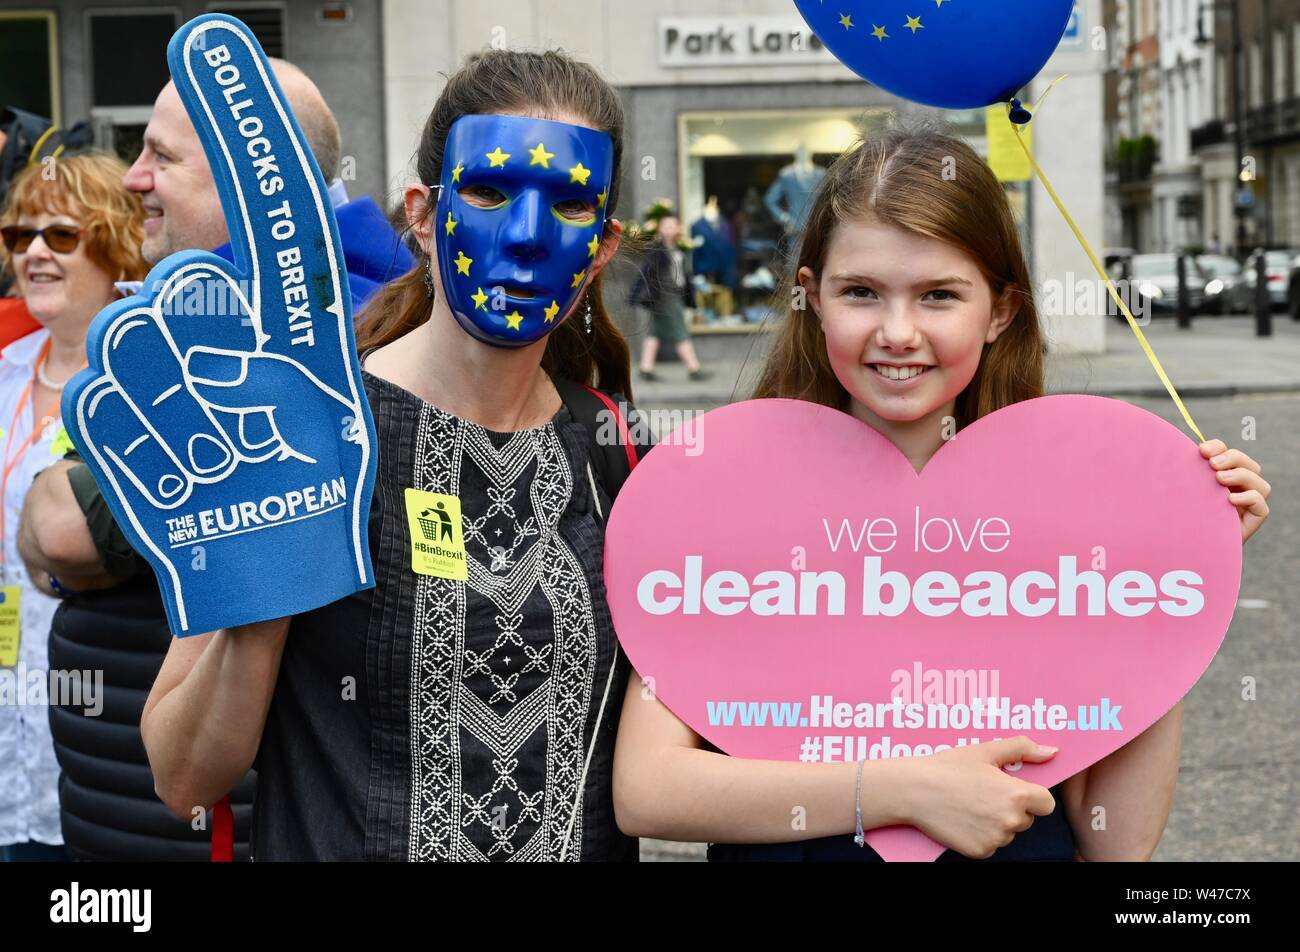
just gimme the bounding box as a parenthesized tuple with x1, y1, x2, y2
(0, 153, 148, 861)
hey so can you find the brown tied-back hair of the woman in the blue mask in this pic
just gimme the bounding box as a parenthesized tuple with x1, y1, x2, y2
(358, 49, 632, 399)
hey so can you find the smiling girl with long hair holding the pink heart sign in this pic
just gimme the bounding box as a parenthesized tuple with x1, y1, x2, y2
(614, 124, 1269, 860)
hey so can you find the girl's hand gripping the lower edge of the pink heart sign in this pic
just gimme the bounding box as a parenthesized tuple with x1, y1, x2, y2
(904, 736, 1057, 860)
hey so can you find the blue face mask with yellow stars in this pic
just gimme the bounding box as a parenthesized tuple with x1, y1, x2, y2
(434, 116, 614, 347)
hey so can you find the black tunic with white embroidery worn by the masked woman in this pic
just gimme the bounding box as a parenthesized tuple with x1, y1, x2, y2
(252, 373, 637, 861)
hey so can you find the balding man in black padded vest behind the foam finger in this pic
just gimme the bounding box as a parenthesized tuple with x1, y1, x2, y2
(18, 60, 415, 860)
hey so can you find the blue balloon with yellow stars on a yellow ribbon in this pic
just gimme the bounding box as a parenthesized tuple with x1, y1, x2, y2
(796, 0, 1074, 109)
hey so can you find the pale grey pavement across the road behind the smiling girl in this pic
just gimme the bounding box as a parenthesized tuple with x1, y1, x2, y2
(633, 312, 1300, 410)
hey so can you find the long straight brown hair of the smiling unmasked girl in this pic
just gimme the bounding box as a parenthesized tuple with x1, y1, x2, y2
(754, 126, 1043, 428)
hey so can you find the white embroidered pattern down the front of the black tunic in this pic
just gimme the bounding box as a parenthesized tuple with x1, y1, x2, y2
(408, 404, 598, 861)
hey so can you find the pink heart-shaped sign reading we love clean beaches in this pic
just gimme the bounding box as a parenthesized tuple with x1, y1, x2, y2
(605, 395, 1242, 860)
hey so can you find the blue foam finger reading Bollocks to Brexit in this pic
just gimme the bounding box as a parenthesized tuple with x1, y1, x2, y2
(62, 14, 376, 636)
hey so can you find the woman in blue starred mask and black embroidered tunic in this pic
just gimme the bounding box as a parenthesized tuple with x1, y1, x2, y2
(144, 51, 650, 860)
